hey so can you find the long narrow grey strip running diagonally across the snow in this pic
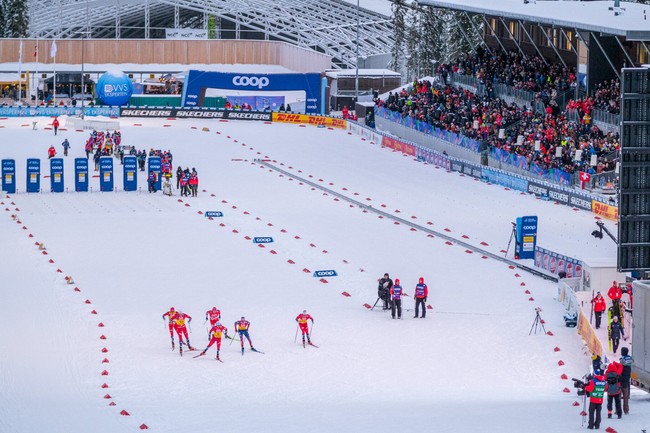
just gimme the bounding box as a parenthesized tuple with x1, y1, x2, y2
(254, 159, 557, 282)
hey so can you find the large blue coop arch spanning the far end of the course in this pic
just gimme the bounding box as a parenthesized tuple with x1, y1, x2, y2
(181, 70, 321, 114)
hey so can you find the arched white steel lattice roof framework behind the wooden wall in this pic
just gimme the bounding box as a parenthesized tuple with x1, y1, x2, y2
(29, 0, 393, 69)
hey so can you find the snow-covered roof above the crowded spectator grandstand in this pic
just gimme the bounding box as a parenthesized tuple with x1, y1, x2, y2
(418, 0, 650, 41)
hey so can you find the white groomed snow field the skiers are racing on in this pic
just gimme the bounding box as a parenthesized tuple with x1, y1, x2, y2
(0, 115, 650, 433)
